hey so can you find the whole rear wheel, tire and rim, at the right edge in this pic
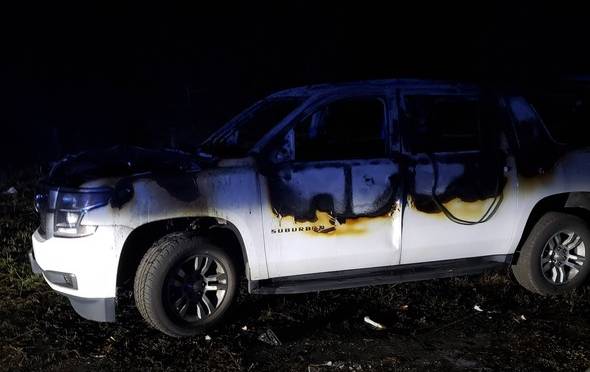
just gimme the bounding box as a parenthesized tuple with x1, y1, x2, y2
(512, 212, 590, 296)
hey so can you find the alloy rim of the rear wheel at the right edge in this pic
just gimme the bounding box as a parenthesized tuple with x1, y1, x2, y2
(541, 230, 586, 285)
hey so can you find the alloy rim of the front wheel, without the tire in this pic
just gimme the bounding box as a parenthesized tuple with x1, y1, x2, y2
(163, 255, 228, 323)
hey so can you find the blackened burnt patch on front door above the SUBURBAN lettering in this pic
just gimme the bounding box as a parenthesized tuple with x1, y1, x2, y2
(268, 160, 400, 222)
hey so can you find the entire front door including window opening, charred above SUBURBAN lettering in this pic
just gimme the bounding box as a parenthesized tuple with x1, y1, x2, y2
(260, 96, 401, 277)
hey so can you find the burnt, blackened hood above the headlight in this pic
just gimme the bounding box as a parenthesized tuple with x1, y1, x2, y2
(46, 146, 201, 187)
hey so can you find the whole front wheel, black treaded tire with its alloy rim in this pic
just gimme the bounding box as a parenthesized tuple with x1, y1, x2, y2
(134, 233, 239, 337)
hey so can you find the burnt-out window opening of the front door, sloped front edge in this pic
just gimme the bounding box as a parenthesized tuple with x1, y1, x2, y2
(295, 97, 387, 161)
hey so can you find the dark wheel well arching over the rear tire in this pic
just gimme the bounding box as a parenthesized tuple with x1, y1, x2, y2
(512, 192, 590, 263)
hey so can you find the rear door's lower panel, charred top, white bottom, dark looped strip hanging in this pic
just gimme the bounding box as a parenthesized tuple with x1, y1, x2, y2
(401, 152, 517, 264)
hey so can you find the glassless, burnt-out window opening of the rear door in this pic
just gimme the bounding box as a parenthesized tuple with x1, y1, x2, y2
(403, 95, 482, 153)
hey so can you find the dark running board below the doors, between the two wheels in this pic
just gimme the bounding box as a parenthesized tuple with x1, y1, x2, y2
(249, 255, 512, 294)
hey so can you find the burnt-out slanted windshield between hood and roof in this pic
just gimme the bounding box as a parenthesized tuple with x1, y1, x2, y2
(202, 97, 304, 157)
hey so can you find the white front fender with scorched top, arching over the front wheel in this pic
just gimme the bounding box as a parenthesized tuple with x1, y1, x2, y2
(83, 161, 268, 280)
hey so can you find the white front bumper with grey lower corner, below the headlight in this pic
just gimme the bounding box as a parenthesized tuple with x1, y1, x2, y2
(29, 226, 128, 322)
